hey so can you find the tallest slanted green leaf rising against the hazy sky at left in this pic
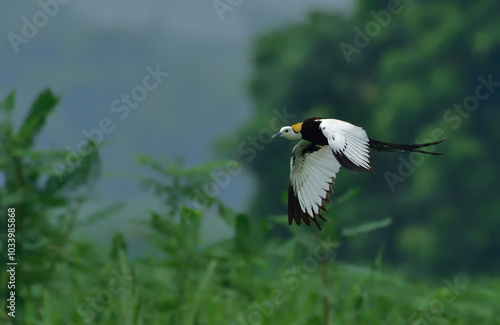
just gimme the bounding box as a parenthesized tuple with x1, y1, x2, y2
(16, 90, 59, 147)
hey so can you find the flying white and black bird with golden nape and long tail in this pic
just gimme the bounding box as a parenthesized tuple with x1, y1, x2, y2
(273, 117, 444, 230)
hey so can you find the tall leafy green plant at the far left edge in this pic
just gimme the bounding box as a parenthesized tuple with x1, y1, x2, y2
(0, 90, 99, 322)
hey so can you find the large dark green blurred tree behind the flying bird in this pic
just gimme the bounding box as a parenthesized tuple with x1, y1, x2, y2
(220, 0, 500, 274)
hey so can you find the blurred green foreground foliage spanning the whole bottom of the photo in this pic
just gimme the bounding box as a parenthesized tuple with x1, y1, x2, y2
(0, 89, 500, 325)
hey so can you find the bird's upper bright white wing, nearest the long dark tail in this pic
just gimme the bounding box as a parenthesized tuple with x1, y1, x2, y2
(319, 119, 371, 171)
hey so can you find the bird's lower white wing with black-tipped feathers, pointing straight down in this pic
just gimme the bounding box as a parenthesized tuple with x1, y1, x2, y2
(288, 140, 340, 229)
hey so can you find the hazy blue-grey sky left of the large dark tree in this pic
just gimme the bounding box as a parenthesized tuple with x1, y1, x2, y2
(0, 0, 351, 242)
